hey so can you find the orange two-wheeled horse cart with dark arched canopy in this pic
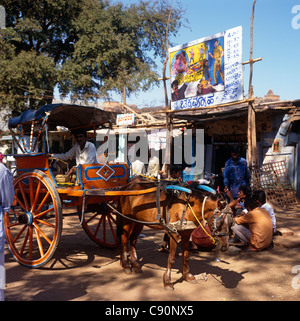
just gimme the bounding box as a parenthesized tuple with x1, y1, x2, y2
(4, 104, 150, 268)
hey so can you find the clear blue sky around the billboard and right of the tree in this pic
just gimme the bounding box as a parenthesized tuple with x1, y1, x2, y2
(121, 0, 300, 107)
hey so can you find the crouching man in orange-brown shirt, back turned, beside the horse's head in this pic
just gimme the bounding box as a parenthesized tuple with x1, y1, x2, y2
(232, 197, 273, 251)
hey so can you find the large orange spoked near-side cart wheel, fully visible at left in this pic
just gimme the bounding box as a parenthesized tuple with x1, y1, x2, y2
(4, 170, 62, 268)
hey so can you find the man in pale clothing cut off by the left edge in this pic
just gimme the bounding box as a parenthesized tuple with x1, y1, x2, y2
(0, 163, 15, 301)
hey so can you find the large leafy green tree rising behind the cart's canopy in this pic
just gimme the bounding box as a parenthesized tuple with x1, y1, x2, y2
(0, 0, 183, 111)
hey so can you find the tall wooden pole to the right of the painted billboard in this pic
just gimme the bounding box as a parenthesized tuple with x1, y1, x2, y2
(247, 0, 257, 168)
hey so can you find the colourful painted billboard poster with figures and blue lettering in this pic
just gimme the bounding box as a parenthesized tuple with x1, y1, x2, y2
(169, 26, 244, 110)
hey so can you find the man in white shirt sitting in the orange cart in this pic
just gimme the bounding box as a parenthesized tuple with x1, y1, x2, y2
(51, 129, 98, 176)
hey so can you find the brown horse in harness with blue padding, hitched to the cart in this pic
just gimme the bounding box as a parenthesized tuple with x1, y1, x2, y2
(120, 179, 232, 290)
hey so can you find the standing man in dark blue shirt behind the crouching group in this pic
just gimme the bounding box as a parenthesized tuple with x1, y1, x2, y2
(224, 146, 250, 200)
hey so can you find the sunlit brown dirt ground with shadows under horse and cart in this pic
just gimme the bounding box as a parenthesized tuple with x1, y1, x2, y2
(5, 206, 300, 302)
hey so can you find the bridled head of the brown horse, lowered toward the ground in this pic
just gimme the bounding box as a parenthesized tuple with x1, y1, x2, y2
(212, 200, 233, 252)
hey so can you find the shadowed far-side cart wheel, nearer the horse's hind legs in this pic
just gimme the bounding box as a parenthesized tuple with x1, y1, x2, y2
(78, 203, 120, 248)
